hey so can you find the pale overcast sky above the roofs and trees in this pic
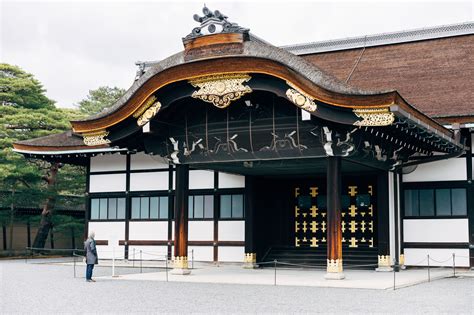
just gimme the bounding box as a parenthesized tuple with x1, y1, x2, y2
(0, 0, 474, 107)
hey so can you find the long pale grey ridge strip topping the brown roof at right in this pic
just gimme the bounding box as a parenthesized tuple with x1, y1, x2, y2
(281, 22, 474, 55)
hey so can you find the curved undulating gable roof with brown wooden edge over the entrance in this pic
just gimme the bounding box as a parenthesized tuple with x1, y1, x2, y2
(71, 34, 396, 132)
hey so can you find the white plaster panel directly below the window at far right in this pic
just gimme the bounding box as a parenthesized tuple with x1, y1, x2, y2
(403, 219, 469, 243)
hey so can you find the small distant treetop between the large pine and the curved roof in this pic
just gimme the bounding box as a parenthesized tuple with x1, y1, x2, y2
(78, 86, 125, 115)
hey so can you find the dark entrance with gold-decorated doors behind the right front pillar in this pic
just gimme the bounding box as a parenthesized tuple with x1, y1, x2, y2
(255, 173, 380, 266)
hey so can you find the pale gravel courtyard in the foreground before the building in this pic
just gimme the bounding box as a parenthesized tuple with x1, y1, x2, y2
(0, 260, 474, 314)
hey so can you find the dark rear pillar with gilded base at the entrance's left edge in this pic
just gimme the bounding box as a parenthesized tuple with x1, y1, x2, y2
(243, 176, 258, 269)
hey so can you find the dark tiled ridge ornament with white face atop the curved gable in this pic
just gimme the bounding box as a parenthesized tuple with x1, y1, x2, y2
(183, 5, 250, 40)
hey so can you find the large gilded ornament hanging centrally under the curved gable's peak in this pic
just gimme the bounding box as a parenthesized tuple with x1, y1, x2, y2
(189, 74, 252, 108)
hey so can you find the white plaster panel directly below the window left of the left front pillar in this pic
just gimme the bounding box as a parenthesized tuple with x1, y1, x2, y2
(128, 221, 168, 241)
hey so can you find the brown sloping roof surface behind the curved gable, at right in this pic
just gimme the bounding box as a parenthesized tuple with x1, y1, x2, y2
(303, 35, 474, 117)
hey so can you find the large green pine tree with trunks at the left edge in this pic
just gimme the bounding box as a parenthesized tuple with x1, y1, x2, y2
(0, 63, 85, 248)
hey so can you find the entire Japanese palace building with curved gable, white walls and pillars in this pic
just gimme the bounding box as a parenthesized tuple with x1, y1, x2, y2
(15, 7, 474, 279)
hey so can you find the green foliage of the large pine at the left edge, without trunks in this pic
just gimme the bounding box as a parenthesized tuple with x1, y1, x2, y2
(0, 64, 85, 209)
